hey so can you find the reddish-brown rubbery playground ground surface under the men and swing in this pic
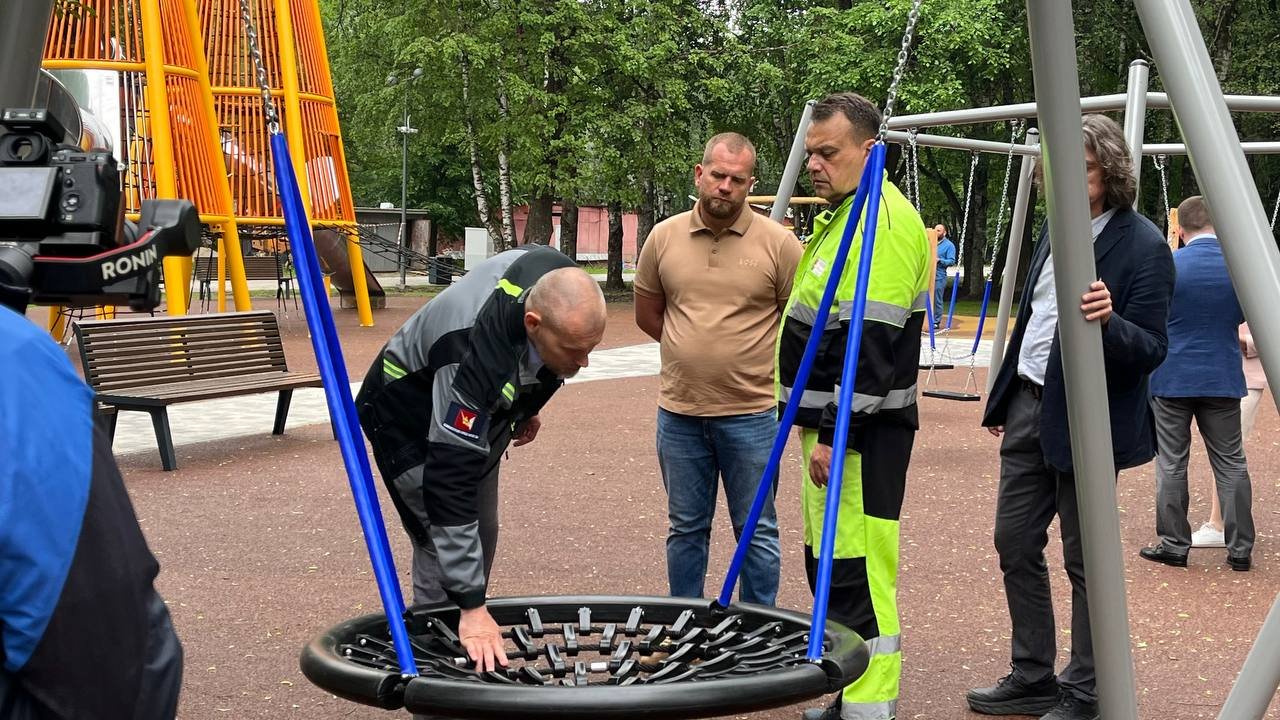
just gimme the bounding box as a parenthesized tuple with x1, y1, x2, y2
(85, 297, 1280, 720)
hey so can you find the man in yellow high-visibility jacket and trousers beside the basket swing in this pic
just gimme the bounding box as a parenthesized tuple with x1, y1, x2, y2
(776, 92, 933, 720)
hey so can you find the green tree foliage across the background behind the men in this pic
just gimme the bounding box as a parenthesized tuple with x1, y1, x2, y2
(320, 0, 1280, 278)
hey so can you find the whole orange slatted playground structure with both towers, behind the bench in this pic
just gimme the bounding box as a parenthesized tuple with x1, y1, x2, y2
(44, 0, 372, 327)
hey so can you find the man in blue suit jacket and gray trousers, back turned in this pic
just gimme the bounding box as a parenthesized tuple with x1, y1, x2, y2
(1142, 195, 1253, 571)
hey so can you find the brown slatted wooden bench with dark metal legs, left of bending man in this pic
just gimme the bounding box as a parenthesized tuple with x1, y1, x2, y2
(74, 310, 321, 470)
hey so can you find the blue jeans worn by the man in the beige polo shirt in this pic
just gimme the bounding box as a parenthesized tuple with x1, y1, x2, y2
(658, 407, 782, 605)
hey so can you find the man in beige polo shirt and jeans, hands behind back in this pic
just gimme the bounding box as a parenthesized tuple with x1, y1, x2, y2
(635, 133, 803, 605)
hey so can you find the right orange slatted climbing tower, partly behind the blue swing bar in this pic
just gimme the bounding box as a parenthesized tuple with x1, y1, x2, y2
(198, 0, 372, 325)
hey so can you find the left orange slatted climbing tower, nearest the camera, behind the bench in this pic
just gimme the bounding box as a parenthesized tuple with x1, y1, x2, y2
(44, 0, 251, 315)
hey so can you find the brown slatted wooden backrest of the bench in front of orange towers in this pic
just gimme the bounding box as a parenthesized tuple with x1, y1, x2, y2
(74, 310, 288, 393)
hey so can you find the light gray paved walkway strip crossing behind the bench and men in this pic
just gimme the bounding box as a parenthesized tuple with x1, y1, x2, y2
(114, 338, 991, 455)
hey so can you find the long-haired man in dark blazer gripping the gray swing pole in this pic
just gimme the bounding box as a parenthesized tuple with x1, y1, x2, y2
(968, 115, 1174, 720)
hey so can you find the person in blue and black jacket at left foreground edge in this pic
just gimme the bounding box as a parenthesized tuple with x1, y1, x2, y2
(0, 306, 182, 720)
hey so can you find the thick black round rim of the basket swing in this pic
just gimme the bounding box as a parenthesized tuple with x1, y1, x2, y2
(300, 596, 869, 720)
